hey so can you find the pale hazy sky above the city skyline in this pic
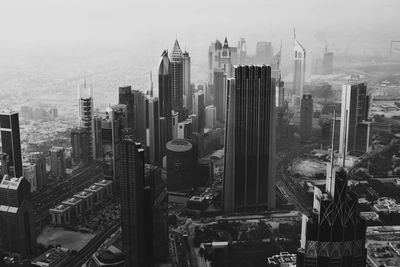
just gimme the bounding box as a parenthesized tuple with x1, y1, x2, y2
(0, 0, 400, 48)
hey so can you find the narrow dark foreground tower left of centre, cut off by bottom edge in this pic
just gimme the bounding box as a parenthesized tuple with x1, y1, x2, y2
(119, 139, 149, 266)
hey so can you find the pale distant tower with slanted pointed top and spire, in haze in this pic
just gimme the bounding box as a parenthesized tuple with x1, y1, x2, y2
(293, 29, 306, 100)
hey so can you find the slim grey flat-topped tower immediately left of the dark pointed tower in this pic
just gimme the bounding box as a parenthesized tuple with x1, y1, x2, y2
(146, 97, 162, 166)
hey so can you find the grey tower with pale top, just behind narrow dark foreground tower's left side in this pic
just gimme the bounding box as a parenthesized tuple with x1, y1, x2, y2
(102, 104, 126, 186)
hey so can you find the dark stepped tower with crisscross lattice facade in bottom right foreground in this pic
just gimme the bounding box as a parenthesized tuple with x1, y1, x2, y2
(296, 168, 367, 267)
